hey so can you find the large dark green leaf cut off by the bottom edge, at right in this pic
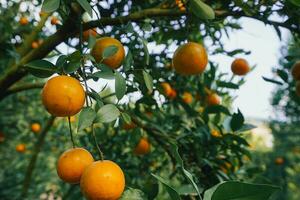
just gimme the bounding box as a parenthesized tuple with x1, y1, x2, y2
(204, 181, 280, 200)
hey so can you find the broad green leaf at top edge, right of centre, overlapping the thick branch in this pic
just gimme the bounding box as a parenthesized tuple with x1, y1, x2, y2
(189, 0, 215, 19)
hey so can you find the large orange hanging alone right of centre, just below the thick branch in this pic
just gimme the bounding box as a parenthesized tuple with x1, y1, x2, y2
(172, 42, 208, 75)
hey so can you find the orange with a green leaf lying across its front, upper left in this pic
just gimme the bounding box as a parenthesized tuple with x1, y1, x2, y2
(91, 37, 125, 69)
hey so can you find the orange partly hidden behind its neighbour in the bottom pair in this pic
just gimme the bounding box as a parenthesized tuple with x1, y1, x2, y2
(56, 148, 94, 183)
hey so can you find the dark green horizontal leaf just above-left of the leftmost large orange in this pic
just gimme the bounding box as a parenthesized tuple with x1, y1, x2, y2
(25, 60, 56, 78)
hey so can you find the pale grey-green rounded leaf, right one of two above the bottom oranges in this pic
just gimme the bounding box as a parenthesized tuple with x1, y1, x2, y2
(95, 104, 120, 123)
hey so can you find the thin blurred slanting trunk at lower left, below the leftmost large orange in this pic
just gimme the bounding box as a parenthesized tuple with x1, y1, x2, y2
(21, 116, 55, 199)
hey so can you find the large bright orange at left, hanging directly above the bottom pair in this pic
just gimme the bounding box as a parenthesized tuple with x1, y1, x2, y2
(42, 76, 85, 117)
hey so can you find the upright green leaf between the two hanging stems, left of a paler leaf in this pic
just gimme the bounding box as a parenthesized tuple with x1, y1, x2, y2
(77, 107, 96, 131)
